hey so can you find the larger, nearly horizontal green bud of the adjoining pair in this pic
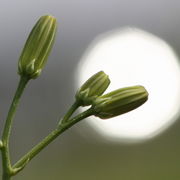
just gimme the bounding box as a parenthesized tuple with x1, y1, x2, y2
(92, 86, 148, 119)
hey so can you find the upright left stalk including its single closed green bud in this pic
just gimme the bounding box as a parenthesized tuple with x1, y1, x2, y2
(0, 15, 57, 180)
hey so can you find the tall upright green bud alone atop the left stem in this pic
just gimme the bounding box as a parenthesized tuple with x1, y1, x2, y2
(18, 15, 57, 79)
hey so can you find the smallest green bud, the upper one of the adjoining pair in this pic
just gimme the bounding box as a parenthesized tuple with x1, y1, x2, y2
(76, 71, 110, 106)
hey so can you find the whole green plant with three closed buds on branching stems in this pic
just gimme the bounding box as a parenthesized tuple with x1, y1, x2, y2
(0, 15, 148, 180)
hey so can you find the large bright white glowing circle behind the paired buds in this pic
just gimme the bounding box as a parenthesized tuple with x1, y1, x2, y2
(77, 29, 180, 141)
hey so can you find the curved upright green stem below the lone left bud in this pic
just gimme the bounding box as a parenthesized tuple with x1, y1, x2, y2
(1, 77, 29, 180)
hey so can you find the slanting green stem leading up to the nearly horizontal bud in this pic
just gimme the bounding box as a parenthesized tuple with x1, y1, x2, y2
(13, 108, 93, 169)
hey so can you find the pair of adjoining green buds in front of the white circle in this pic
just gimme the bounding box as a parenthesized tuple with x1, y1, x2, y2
(76, 71, 148, 119)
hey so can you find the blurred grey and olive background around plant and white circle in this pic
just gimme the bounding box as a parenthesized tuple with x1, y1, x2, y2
(0, 0, 180, 180)
